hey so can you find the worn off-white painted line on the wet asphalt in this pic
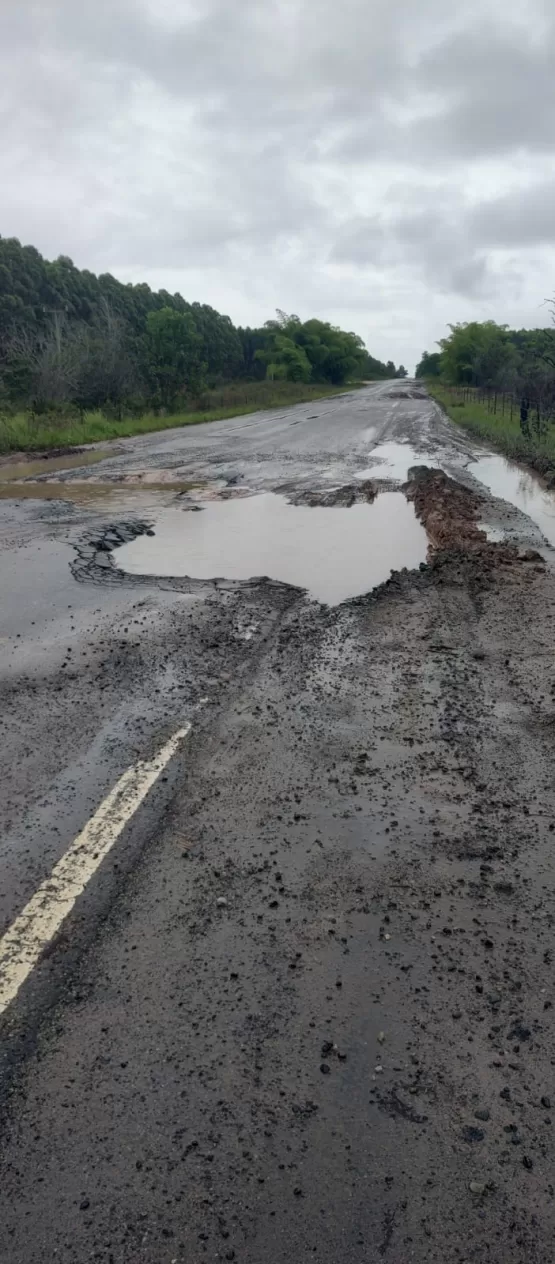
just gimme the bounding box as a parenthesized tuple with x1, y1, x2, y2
(0, 724, 191, 1015)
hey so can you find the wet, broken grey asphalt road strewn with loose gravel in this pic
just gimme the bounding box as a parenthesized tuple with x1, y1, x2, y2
(0, 383, 555, 1264)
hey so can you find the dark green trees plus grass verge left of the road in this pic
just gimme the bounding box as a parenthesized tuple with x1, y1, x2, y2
(0, 238, 406, 453)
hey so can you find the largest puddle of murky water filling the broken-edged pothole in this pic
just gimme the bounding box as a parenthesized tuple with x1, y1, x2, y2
(115, 492, 427, 605)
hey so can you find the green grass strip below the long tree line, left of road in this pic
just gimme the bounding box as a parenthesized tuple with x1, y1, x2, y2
(0, 382, 362, 454)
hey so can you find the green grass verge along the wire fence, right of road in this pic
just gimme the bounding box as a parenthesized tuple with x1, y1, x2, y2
(426, 379, 555, 474)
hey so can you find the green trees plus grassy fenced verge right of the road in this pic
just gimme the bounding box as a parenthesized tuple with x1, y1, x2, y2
(416, 321, 555, 479)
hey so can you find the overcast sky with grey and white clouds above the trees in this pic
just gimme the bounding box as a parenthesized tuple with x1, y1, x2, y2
(0, 0, 555, 369)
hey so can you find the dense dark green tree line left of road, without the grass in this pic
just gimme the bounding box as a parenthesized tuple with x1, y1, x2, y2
(0, 238, 406, 413)
